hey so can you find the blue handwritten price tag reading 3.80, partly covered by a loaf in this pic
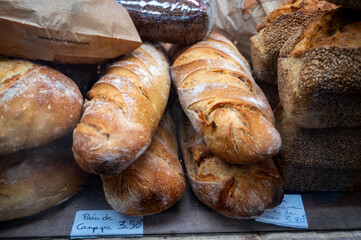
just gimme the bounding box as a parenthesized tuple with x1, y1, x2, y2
(255, 194, 308, 228)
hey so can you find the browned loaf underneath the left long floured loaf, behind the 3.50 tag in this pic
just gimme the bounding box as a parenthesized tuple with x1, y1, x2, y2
(101, 114, 185, 216)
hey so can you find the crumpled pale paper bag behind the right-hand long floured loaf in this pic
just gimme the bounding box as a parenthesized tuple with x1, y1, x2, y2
(213, 0, 287, 62)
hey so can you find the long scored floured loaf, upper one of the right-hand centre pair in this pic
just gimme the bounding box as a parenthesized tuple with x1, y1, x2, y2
(171, 32, 281, 163)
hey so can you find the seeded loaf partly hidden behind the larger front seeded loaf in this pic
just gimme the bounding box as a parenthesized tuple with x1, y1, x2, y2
(251, 0, 336, 84)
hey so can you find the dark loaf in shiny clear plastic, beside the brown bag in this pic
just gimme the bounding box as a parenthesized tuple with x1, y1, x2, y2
(118, 0, 215, 44)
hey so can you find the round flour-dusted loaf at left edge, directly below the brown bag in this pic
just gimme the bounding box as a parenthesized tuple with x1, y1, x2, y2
(0, 58, 83, 156)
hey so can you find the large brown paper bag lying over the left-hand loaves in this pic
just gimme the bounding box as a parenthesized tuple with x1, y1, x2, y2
(0, 0, 141, 63)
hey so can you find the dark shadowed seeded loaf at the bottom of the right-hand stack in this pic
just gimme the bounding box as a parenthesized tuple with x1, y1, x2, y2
(274, 106, 361, 191)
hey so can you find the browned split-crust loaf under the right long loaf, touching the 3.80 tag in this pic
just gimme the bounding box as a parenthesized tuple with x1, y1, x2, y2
(180, 118, 283, 218)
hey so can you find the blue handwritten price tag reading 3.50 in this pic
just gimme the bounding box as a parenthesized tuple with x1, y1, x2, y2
(70, 210, 143, 238)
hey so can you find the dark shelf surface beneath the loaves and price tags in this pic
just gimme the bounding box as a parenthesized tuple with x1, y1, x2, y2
(0, 175, 361, 238)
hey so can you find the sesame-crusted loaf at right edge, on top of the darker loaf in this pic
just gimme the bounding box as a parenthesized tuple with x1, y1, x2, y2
(278, 8, 361, 128)
